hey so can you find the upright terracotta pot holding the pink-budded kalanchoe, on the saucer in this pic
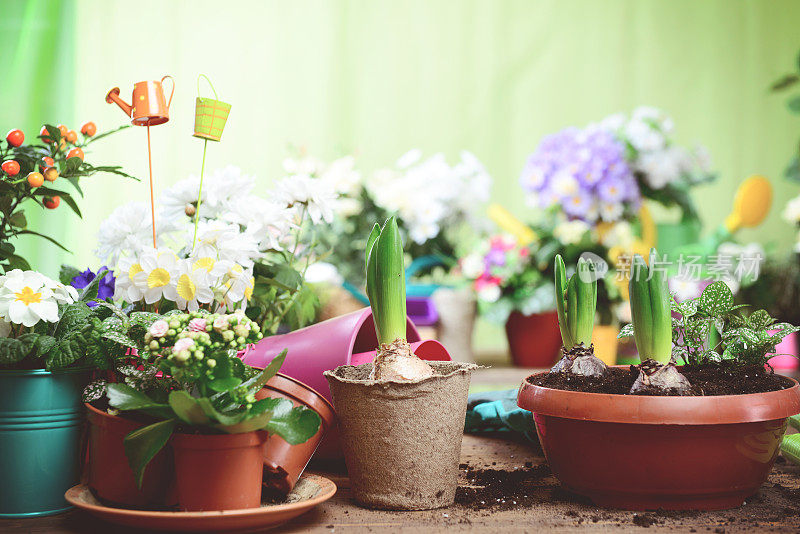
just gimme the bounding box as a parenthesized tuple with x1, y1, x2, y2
(172, 431, 267, 512)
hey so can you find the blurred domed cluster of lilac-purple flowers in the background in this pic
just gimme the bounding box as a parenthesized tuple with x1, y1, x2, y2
(520, 127, 640, 223)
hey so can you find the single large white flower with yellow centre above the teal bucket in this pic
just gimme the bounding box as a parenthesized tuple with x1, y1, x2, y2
(0, 269, 58, 327)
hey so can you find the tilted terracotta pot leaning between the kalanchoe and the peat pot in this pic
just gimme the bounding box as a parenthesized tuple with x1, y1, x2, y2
(256, 373, 336, 495)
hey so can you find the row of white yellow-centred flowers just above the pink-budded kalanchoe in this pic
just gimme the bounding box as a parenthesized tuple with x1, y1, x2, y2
(114, 248, 255, 311)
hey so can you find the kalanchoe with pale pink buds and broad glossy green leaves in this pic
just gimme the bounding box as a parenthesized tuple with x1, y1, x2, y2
(106, 312, 321, 485)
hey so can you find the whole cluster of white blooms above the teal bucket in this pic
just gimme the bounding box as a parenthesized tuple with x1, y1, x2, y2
(0, 269, 78, 337)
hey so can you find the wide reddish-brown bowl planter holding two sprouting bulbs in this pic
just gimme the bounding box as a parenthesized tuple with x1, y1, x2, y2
(517, 379, 800, 510)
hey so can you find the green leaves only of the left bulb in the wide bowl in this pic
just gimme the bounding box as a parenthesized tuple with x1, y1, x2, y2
(554, 254, 597, 350)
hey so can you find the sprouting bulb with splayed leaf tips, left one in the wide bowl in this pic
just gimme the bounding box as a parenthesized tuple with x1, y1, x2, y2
(552, 254, 608, 376)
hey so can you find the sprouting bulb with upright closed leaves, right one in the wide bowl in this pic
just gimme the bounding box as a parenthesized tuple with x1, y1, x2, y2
(619, 249, 691, 395)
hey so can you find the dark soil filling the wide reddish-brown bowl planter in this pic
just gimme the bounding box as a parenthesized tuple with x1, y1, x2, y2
(528, 364, 794, 396)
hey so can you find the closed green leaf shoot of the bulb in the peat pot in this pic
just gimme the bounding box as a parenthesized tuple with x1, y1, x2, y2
(366, 217, 406, 343)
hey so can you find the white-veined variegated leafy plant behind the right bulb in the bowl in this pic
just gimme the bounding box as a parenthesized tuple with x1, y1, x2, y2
(672, 282, 800, 366)
